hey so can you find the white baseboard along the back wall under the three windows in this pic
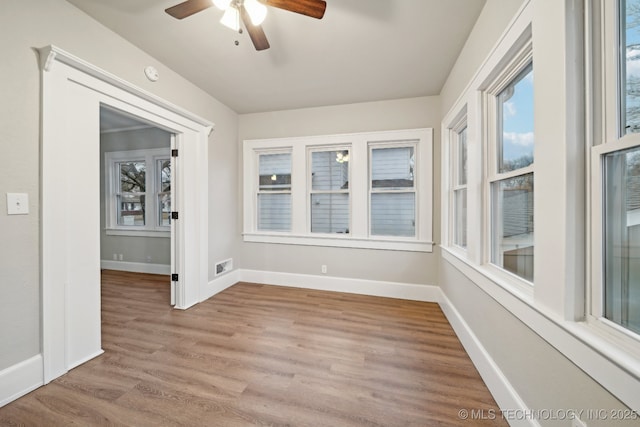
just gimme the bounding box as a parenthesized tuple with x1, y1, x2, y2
(239, 270, 440, 302)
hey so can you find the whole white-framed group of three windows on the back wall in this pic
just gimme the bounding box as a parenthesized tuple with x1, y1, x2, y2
(244, 129, 433, 252)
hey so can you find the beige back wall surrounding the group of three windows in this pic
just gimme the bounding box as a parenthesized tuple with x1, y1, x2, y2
(237, 97, 440, 285)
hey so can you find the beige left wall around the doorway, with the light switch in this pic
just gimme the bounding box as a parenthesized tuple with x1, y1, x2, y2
(0, 0, 238, 370)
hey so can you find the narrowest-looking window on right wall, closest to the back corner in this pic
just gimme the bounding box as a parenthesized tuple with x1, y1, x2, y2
(451, 123, 467, 248)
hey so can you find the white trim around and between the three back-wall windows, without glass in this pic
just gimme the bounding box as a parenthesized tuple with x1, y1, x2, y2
(243, 128, 434, 252)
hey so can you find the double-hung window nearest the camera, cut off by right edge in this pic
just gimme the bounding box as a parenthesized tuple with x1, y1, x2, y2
(590, 0, 640, 339)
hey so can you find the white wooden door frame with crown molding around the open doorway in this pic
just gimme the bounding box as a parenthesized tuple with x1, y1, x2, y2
(39, 46, 213, 384)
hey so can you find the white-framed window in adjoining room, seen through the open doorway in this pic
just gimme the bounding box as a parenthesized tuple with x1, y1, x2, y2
(105, 149, 171, 235)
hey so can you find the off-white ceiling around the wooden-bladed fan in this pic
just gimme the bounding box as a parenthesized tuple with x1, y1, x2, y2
(67, 0, 485, 113)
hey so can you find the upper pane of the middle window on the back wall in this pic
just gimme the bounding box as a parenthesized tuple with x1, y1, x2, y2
(311, 150, 349, 190)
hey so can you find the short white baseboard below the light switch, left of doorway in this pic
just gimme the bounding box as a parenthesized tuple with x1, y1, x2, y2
(0, 354, 44, 407)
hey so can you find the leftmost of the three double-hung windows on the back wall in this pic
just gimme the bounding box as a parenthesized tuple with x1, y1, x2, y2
(257, 152, 291, 231)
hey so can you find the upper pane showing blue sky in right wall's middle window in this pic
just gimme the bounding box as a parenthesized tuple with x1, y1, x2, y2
(497, 64, 534, 173)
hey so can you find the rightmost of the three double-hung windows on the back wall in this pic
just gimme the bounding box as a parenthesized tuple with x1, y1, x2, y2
(369, 144, 416, 237)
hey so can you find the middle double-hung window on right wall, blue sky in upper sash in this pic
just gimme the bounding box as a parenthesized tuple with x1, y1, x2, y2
(489, 57, 534, 282)
